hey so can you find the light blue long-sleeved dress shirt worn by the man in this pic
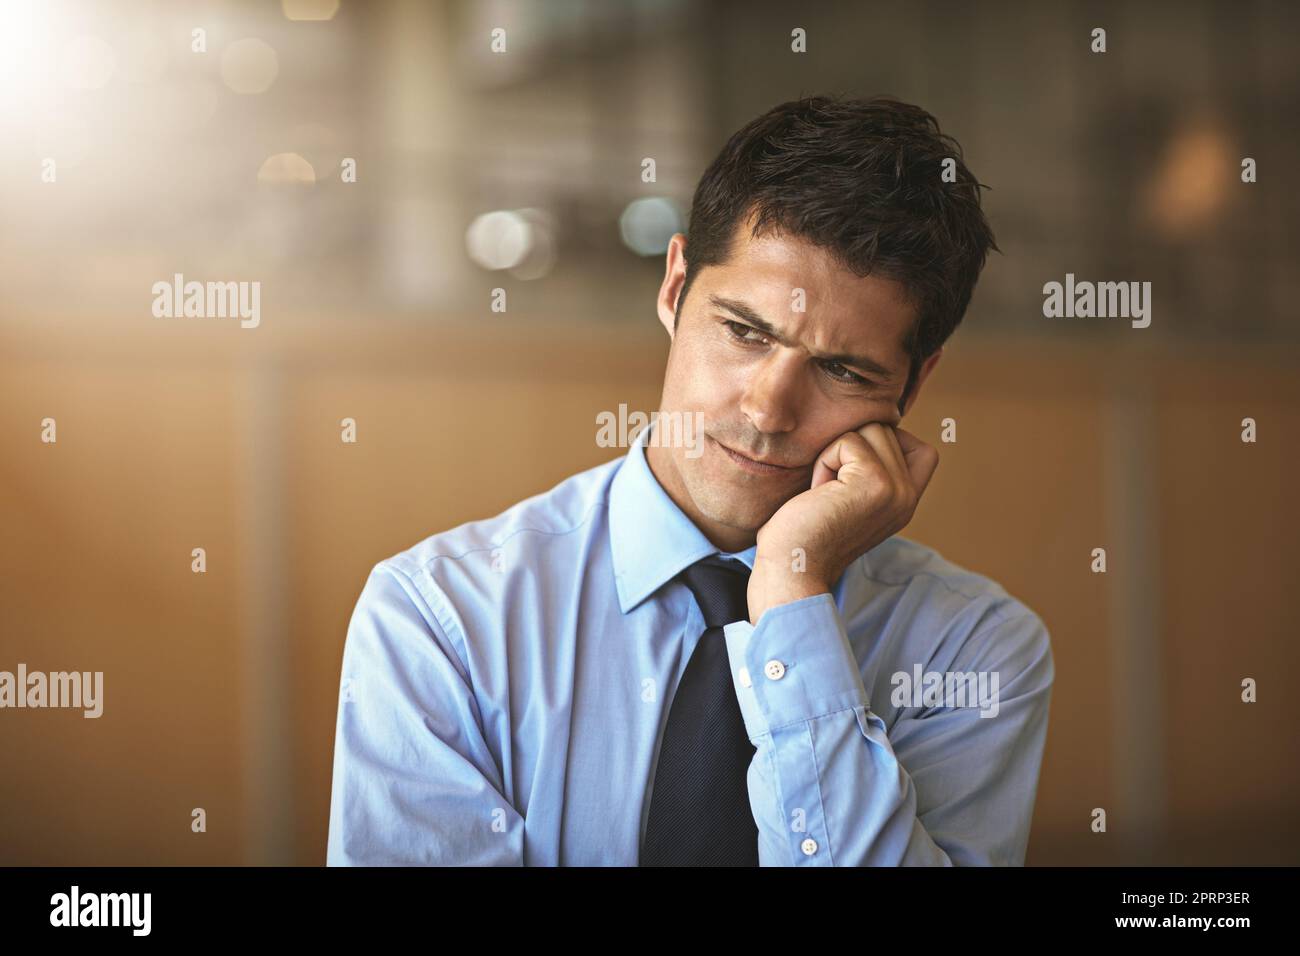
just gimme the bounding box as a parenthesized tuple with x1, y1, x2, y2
(326, 418, 1054, 866)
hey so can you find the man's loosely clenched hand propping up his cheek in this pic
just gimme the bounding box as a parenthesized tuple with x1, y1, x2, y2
(748, 421, 939, 626)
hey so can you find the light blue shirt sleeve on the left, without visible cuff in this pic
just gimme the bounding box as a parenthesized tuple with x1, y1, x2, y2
(326, 563, 524, 866)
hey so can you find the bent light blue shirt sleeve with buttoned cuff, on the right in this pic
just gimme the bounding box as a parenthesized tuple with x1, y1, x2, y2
(725, 593, 1054, 866)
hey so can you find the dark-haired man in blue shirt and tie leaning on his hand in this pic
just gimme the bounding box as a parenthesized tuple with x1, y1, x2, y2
(328, 98, 1053, 866)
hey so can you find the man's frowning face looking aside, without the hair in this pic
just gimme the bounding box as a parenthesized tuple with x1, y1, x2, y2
(646, 214, 937, 550)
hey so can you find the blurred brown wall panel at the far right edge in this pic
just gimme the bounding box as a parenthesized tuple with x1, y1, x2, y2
(1157, 363, 1300, 865)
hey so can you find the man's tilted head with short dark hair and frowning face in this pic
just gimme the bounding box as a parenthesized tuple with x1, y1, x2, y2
(647, 96, 997, 550)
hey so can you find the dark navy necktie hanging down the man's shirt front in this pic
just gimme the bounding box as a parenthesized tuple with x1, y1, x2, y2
(640, 555, 758, 866)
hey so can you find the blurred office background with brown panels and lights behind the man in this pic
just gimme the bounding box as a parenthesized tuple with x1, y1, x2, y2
(0, 0, 1300, 864)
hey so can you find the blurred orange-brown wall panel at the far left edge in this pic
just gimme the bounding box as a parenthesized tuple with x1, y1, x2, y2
(0, 362, 243, 865)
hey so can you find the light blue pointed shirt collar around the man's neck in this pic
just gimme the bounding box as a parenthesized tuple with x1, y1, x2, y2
(610, 421, 758, 614)
